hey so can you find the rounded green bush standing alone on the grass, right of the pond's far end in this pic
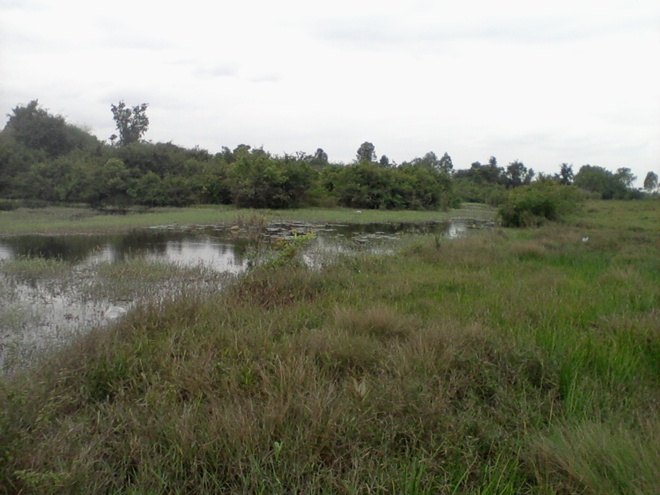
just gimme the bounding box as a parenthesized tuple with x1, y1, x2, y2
(498, 181, 580, 227)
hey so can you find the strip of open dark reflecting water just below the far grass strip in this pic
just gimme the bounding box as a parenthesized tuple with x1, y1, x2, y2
(0, 222, 469, 273)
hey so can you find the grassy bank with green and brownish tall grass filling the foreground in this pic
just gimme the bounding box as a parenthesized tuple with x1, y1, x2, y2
(0, 203, 660, 494)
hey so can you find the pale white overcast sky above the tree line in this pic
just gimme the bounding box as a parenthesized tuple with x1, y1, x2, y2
(0, 0, 660, 184)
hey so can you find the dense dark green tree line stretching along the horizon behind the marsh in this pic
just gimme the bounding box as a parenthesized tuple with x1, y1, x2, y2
(0, 100, 657, 209)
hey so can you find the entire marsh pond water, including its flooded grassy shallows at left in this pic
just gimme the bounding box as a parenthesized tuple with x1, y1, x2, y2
(0, 220, 483, 373)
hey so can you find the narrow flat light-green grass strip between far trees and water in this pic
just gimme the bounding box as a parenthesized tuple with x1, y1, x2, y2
(0, 204, 494, 235)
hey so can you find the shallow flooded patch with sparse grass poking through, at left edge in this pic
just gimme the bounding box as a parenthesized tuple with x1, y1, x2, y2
(0, 257, 232, 374)
